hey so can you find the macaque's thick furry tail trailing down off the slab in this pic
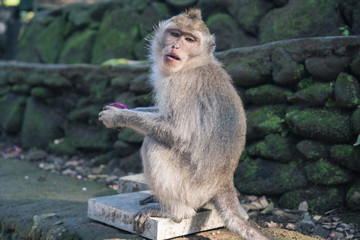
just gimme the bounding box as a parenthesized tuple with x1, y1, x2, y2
(213, 189, 270, 240)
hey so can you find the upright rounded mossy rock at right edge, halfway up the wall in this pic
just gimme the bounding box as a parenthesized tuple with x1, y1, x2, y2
(335, 72, 360, 108)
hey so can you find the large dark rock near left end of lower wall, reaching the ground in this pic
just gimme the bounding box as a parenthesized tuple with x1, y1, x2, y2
(21, 97, 64, 148)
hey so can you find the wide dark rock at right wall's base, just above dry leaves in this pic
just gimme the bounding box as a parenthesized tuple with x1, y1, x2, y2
(279, 186, 345, 214)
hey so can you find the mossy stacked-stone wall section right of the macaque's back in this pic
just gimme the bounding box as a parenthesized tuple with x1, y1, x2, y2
(219, 38, 360, 211)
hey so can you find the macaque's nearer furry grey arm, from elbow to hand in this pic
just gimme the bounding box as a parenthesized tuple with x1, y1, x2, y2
(99, 106, 180, 146)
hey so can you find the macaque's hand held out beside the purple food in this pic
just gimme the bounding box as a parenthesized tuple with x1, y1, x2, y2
(99, 106, 129, 128)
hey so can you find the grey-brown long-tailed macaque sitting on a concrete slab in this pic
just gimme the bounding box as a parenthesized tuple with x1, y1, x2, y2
(99, 9, 268, 240)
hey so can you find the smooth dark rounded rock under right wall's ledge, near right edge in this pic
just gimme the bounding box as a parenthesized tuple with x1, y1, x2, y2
(305, 56, 349, 82)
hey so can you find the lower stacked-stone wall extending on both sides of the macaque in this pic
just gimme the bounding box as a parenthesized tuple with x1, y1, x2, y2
(0, 37, 360, 211)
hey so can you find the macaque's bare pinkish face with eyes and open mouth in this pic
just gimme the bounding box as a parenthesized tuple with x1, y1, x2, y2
(160, 28, 201, 73)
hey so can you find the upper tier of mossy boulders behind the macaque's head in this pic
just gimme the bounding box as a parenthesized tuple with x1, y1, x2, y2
(16, 0, 360, 64)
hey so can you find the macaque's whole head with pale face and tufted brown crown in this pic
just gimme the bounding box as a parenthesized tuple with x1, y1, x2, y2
(150, 9, 215, 75)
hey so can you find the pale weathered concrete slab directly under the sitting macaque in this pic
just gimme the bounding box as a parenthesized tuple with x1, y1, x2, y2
(88, 191, 224, 240)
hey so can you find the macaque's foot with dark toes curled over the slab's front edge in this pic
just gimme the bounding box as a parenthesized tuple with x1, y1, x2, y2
(133, 203, 162, 234)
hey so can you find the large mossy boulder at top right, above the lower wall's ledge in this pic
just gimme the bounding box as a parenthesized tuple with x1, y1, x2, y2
(258, 0, 344, 43)
